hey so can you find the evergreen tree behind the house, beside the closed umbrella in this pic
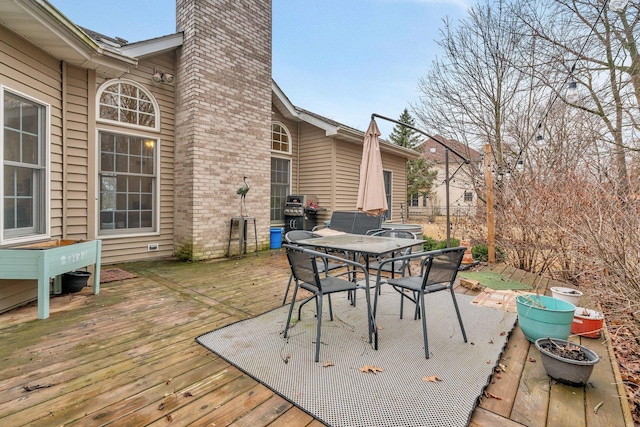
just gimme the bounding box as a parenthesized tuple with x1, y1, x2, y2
(389, 108, 438, 202)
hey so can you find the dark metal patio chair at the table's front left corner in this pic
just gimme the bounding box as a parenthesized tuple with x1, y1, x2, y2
(283, 244, 374, 362)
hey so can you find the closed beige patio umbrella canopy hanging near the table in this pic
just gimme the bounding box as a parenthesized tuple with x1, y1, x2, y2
(356, 120, 387, 216)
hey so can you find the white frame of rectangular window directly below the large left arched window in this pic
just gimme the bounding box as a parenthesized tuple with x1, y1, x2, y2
(96, 128, 162, 239)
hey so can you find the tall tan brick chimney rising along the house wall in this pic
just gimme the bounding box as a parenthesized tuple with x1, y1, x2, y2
(174, 0, 271, 260)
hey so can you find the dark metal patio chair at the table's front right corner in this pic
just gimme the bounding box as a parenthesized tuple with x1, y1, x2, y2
(373, 246, 467, 359)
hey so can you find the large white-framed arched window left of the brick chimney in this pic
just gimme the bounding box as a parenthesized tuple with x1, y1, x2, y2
(98, 80, 160, 130)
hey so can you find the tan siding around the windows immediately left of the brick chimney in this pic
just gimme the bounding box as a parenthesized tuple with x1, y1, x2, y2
(94, 53, 175, 264)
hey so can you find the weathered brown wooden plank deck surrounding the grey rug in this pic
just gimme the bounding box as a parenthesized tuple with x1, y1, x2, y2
(0, 250, 633, 427)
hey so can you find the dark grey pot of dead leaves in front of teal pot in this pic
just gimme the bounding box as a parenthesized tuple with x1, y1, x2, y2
(535, 338, 600, 386)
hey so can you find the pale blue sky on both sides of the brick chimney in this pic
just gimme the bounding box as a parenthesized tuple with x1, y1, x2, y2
(49, 0, 471, 138)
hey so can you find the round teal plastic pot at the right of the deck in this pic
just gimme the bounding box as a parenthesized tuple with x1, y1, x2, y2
(516, 295, 576, 342)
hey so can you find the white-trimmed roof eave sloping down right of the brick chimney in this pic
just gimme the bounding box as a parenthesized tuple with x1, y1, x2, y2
(271, 80, 420, 159)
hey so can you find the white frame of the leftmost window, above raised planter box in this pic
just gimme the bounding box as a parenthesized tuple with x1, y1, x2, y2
(0, 85, 51, 245)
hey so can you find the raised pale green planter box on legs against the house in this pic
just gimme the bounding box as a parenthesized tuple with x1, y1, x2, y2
(0, 240, 102, 319)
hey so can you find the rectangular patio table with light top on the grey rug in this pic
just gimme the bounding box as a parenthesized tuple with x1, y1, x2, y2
(297, 233, 423, 350)
